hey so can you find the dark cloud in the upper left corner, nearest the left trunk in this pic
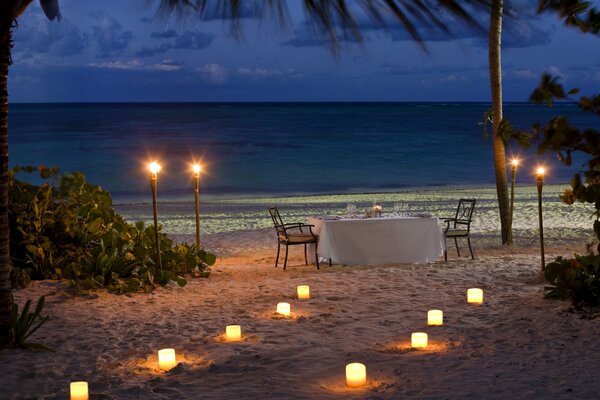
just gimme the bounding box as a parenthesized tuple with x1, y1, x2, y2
(14, 13, 89, 58)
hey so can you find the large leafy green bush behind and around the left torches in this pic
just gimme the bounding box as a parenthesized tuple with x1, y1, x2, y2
(9, 166, 216, 293)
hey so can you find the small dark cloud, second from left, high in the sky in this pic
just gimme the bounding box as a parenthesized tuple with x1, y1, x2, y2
(91, 11, 133, 58)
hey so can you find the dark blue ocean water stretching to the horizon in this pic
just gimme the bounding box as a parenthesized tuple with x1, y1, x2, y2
(9, 103, 598, 202)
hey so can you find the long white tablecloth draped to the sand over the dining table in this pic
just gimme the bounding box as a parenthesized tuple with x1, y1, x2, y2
(308, 217, 446, 265)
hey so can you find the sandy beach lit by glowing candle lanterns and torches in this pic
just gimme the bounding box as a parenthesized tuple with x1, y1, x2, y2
(0, 187, 600, 399)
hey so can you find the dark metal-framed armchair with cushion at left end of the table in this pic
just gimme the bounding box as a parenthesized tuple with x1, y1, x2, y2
(269, 207, 320, 271)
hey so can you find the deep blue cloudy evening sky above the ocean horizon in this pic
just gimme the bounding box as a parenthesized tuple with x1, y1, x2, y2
(9, 0, 600, 102)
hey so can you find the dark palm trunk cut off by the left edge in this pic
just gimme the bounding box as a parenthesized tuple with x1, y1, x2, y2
(0, 27, 13, 349)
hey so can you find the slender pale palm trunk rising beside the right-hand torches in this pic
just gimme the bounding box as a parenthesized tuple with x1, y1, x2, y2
(488, 0, 510, 244)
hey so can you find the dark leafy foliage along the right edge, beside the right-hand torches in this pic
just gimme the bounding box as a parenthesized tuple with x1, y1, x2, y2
(515, 74, 600, 307)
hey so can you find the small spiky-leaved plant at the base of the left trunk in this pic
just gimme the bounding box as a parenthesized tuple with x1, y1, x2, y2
(12, 296, 52, 351)
